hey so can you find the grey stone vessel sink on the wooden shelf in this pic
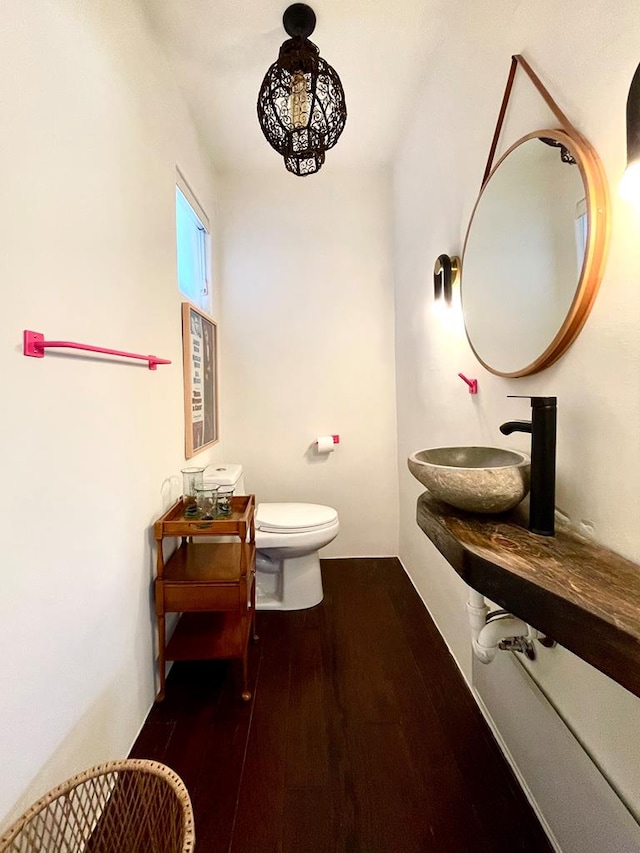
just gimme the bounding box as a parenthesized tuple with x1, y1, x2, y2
(407, 447, 531, 513)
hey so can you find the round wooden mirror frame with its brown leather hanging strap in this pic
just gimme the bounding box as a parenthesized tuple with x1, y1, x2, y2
(461, 55, 609, 378)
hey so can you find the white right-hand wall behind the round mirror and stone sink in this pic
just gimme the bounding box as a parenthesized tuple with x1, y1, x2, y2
(394, 0, 640, 840)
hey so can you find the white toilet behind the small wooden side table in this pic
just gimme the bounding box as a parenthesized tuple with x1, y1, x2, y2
(204, 464, 340, 610)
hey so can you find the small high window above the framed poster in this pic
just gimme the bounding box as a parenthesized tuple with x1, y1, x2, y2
(176, 172, 211, 313)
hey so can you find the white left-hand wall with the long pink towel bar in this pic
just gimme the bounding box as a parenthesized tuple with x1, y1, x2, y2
(0, 0, 221, 822)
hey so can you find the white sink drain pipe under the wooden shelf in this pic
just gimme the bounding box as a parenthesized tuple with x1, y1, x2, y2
(467, 587, 540, 663)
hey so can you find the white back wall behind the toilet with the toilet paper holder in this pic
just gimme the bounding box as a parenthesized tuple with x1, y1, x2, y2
(221, 171, 398, 557)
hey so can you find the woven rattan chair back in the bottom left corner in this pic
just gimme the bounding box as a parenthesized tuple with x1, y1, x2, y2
(0, 759, 195, 853)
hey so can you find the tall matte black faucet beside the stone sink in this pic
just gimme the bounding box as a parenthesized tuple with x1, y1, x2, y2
(500, 394, 557, 536)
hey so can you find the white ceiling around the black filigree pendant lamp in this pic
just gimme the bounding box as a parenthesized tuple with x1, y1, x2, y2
(138, 0, 446, 171)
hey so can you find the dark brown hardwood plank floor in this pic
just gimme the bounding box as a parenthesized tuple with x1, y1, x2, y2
(131, 558, 551, 853)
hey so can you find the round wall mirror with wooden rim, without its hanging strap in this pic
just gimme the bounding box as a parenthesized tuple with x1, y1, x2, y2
(461, 130, 607, 377)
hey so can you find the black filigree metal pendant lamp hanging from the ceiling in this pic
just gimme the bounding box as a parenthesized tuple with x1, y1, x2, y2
(258, 3, 347, 176)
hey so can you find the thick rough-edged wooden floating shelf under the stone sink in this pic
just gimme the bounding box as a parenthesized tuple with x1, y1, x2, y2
(417, 492, 640, 696)
